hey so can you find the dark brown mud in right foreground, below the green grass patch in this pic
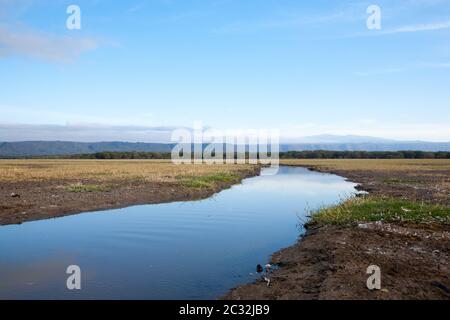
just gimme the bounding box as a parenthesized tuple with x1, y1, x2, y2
(223, 225, 450, 300)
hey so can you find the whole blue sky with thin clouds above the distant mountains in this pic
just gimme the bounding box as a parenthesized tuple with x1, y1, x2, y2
(0, 0, 450, 141)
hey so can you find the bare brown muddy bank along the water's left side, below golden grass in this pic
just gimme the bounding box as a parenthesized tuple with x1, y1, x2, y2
(0, 168, 260, 225)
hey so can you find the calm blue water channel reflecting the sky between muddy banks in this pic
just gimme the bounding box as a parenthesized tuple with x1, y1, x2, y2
(0, 167, 356, 299)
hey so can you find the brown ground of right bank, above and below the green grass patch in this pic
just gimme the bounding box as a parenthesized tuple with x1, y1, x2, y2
(223, 160, 450, 300)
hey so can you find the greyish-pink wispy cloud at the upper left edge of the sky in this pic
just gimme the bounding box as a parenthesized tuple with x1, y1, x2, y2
(0, 26, 98, 63)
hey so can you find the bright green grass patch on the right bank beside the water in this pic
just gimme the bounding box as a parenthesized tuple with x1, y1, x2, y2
(311, 196, 450, 225)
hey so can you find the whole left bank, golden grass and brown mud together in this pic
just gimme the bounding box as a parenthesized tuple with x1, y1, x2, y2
(0, 160, 259, 224)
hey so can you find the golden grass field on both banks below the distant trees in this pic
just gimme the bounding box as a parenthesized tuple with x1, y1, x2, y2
(0, 159, 450, 189)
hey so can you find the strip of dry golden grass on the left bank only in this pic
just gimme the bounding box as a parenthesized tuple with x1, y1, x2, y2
(0, 160, 255, 183)
